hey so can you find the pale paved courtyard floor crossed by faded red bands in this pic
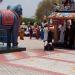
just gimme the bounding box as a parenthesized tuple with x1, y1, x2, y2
(0, 37, 75, 75)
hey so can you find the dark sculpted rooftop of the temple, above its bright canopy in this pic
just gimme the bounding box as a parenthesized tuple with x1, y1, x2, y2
(56, 0, 75, 12)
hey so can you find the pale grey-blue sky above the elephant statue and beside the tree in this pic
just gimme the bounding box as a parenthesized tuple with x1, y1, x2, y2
(0, 0, 42, 18)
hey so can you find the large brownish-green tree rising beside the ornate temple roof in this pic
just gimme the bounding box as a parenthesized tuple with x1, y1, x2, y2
(36, 0, 60, 19)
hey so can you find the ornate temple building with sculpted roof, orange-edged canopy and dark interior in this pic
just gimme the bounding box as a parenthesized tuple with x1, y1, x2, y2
(48, 0, 75, 49)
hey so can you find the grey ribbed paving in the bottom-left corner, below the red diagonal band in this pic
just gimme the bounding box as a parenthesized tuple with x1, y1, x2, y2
(0, 63, 53, 75)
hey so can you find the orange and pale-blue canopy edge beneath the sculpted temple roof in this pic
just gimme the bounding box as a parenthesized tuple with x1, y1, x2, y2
(48, 12, 75, 19)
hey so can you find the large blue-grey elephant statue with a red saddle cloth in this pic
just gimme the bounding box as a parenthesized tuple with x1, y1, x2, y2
(0, 5, 22, 48)
